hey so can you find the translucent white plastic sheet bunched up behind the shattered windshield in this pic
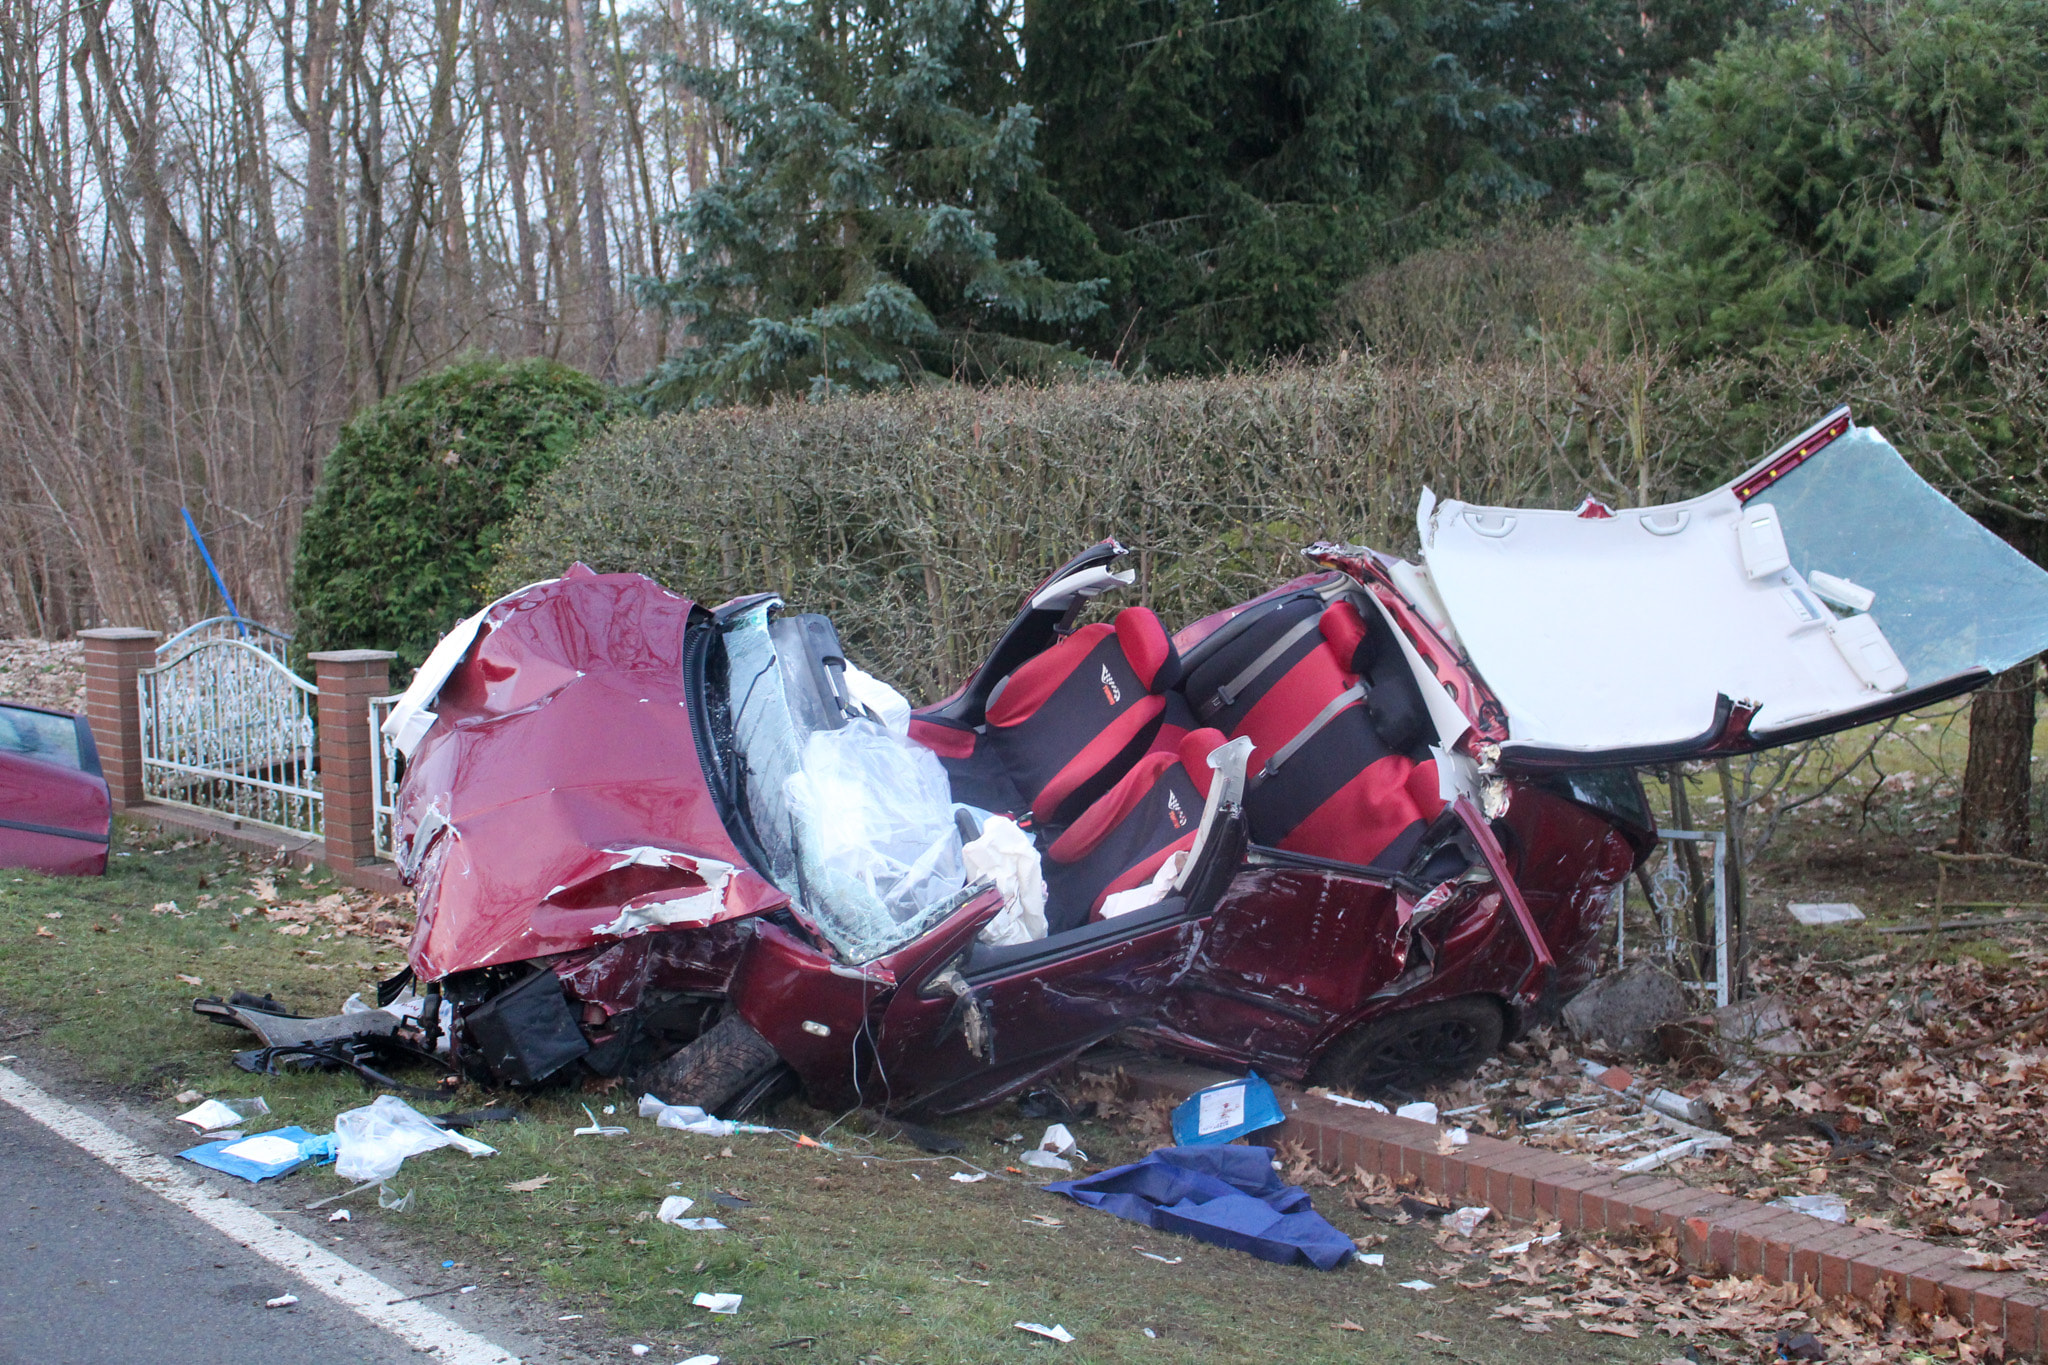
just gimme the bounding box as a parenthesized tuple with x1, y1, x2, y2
(786, 720, 967, 943)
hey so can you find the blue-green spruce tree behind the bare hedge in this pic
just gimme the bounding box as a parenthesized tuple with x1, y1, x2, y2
(639, 0, 1106, 407)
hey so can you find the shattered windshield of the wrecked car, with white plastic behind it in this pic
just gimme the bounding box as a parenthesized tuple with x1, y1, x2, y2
(725, 602, 967, 962)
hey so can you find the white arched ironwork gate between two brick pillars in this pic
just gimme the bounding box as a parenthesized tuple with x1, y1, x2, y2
(137, 634, 322, 835)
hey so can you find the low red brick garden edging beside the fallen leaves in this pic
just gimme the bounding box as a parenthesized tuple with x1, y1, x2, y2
(1116, 1056, 2048, 1359)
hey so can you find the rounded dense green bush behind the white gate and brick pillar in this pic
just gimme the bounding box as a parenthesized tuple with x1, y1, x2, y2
(291, 360, 618, 677)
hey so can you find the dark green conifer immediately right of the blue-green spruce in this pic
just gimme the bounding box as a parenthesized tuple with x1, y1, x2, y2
(1024, 0, 1542, 370)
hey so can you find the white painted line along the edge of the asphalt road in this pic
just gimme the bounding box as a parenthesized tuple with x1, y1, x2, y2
(0, 1066, 518, 1365)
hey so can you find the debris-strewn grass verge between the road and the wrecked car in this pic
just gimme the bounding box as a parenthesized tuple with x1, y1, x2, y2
(0, 829, 1677, 1363)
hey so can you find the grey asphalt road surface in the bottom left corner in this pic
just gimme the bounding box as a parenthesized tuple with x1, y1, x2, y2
(0, 1105, 432, 1365)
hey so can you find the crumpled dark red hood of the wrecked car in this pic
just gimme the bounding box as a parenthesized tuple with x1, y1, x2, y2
(393, 565, 788, 980)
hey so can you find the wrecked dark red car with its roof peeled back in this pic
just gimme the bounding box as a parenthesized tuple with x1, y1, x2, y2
(387, 409, 2048, 1115)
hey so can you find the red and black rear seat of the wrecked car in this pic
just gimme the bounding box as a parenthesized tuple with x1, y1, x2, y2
(1188, 593, 1444, 866)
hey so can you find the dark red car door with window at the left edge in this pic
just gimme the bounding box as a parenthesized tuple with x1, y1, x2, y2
(0, 702, 113, 876)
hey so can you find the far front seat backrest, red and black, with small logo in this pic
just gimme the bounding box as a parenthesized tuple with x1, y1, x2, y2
(978, 606, 1188, 825)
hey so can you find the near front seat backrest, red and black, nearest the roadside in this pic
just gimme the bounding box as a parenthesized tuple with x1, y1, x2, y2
(1044, 729, 1223, 933)
